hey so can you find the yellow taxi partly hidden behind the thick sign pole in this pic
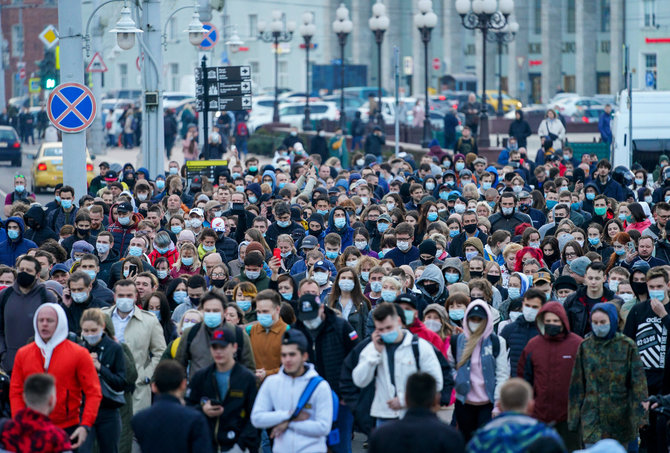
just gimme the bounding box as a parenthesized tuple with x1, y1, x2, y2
(30, 142, 95, 193)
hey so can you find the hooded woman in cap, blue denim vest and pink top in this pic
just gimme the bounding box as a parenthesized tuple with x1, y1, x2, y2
(448, 299, 510, 442)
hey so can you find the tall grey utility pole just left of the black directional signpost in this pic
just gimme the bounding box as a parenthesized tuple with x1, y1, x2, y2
(141, 0, 165, 178)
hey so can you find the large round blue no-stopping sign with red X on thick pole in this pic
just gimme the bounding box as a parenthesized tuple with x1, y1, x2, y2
(47, 82, 96, 132)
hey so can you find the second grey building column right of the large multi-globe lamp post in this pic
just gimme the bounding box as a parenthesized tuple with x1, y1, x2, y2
(542, 0, 562, 102)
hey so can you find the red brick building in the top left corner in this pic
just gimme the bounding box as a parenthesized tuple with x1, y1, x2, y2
(0, 0, 58, 99)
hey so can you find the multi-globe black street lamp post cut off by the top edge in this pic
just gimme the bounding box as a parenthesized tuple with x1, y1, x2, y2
(456, 0, 514, 149)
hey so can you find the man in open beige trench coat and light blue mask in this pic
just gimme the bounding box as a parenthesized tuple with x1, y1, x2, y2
(103, 280, 165, 413)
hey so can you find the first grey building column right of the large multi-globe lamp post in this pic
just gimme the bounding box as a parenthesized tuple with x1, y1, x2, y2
(507, 0, 531, 105)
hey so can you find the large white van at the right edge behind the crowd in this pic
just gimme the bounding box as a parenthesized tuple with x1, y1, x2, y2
(612, 90, 670, 171)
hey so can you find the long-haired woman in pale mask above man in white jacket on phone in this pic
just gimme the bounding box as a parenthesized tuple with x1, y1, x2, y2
(328, 267, 371, 338)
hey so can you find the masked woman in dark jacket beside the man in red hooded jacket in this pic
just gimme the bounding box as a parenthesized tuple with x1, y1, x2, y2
(80, 308, 127, 453)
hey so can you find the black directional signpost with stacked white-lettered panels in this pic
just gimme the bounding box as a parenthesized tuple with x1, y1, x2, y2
(195, 57, 251, 158)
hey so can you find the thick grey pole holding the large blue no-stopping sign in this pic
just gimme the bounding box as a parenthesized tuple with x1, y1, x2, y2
(58, 0, 87, 200)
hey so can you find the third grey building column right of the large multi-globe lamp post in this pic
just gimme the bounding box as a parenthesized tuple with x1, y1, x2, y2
(575, 0, 600, 96)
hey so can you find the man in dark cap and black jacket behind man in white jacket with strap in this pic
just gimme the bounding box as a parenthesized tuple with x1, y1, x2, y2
(292, 292, 360, 453)
